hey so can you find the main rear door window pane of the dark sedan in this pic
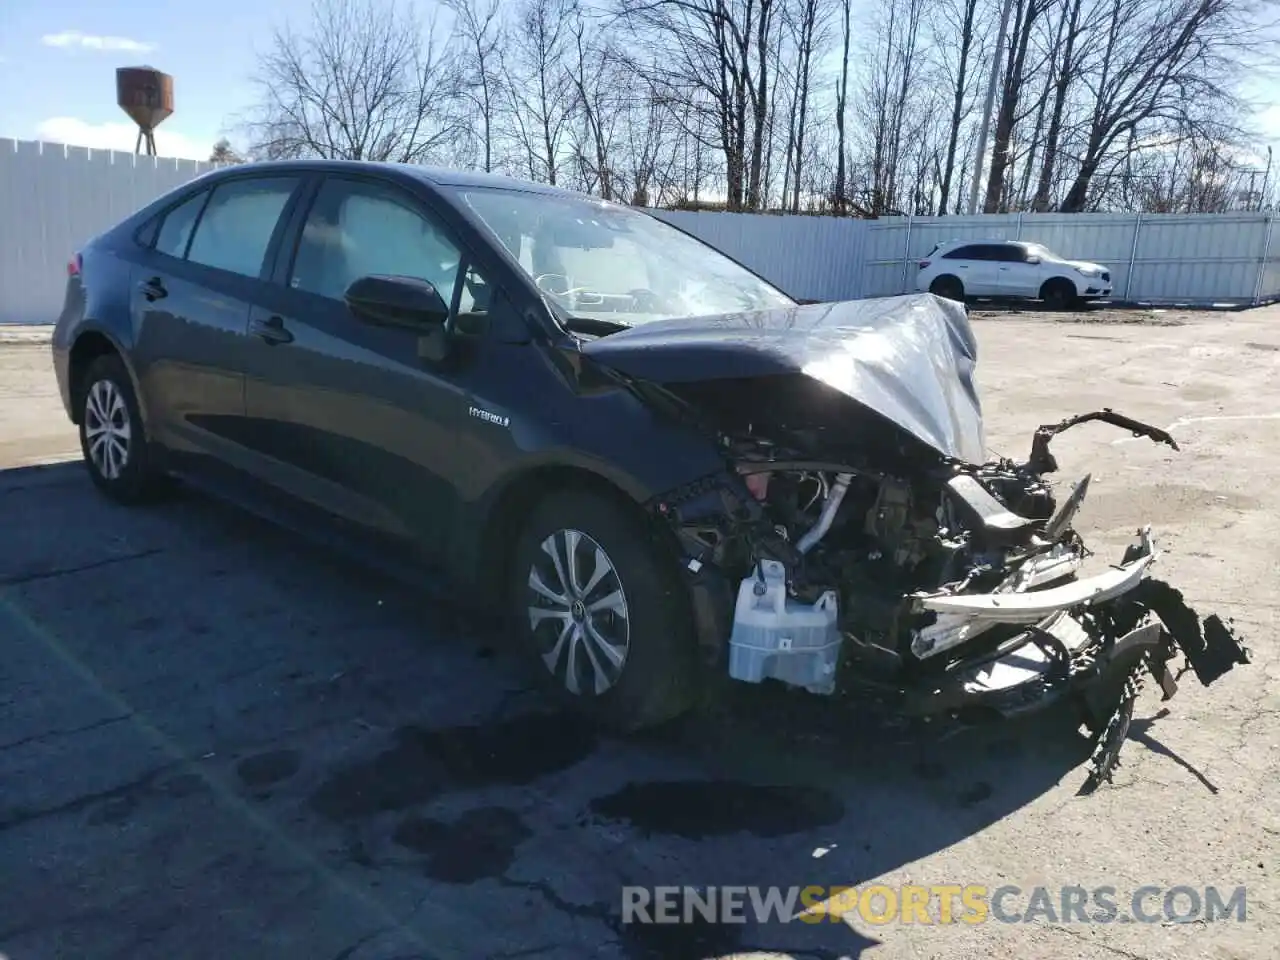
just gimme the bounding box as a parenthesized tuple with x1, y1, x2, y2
(187, 177, 297, 278)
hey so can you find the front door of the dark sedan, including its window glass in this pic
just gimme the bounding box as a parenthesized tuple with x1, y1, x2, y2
(246, 177, 468, 554)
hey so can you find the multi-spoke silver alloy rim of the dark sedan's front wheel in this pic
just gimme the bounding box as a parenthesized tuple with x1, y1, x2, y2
(529, 530, 631, 696)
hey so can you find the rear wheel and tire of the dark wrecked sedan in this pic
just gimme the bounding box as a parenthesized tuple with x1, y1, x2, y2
(76, 353, 166, 504)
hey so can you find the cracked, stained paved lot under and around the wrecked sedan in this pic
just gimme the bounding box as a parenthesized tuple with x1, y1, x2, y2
(0, 308, 1280, 960)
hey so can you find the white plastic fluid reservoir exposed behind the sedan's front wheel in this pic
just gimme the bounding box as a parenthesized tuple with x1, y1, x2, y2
(728, 561, 841, 694)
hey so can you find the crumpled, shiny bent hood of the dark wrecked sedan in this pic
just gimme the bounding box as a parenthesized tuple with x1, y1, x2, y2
(582, 293, 986, 463)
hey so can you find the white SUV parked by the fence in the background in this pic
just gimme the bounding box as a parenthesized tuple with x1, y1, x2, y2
(915, 241, 1111, 310)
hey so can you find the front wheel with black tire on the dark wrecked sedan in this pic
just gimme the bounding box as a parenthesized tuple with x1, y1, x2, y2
(507, 490, 696, 732)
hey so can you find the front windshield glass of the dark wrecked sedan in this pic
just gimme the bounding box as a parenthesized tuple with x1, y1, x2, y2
(462, 189, 795, 326)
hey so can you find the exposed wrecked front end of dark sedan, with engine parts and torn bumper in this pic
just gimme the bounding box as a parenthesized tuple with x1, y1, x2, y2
(658, 410, 1248, 781)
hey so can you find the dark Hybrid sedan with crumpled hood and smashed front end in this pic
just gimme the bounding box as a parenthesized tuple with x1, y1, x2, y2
(54, 161, 1247, 776)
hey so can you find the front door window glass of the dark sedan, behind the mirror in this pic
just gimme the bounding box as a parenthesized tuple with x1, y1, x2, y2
(289, 178, 462, 303)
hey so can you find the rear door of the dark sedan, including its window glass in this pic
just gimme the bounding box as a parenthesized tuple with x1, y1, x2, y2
(131, 177, 301, 463)
